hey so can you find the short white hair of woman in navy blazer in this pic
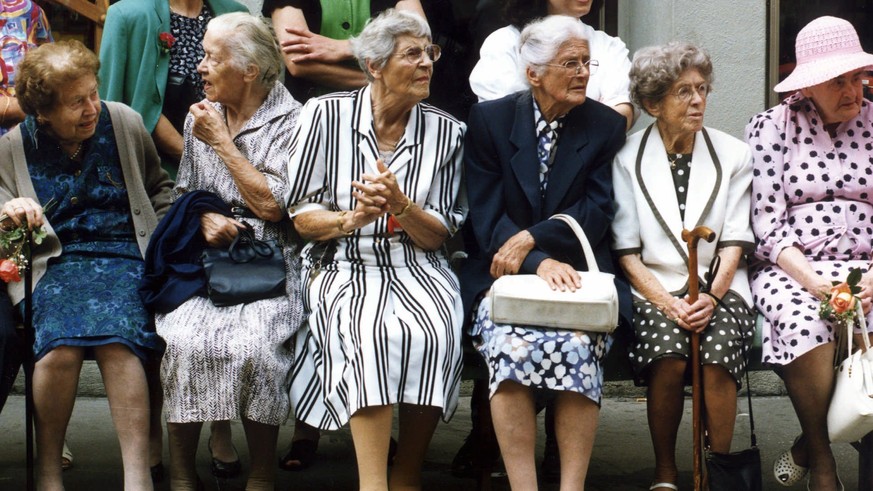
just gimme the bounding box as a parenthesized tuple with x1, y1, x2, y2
(518, 15, 590, 80)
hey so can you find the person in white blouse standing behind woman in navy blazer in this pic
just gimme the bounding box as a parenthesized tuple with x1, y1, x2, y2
(470, 0, 636, 128)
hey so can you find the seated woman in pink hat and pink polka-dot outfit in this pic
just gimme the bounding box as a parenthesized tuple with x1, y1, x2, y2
(746, 17, 873, 490)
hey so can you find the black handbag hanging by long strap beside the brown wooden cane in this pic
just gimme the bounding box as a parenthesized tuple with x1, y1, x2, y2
(706, 256, 763, 491)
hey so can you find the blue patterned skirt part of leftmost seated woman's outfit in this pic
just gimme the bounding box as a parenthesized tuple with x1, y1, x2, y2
(19, 242, 163, 360)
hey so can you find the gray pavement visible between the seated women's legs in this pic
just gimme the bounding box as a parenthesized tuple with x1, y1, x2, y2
(0, 395, 858, 491)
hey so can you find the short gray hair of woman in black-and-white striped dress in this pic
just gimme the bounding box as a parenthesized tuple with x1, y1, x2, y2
(349, 9, 432, 82)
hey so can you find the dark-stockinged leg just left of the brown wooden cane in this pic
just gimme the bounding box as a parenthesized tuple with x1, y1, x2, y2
(646, 357, 686, 483)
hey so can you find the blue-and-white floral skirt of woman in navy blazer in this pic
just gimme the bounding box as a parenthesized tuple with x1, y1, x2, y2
(470, 296, 612, 404)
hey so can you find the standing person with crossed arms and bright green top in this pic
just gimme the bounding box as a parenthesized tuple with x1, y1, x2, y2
(264, 0, 424, 103)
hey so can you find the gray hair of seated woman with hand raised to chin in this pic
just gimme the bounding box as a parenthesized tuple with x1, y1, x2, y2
(206, 12, 284, 89)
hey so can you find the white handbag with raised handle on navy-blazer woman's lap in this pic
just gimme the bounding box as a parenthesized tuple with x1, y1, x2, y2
(490, 214, 618, 333)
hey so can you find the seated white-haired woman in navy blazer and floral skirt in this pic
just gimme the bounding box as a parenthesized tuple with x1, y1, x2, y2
(462, 16, 630, 489)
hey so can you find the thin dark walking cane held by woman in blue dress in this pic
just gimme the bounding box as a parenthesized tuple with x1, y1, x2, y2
(24, 228, 36, 491)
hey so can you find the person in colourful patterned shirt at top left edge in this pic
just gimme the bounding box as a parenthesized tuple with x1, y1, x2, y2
(0, 0, 53, 135)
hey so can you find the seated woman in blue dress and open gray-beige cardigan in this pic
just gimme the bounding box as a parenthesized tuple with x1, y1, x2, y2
(0, 41, 172, 490)
